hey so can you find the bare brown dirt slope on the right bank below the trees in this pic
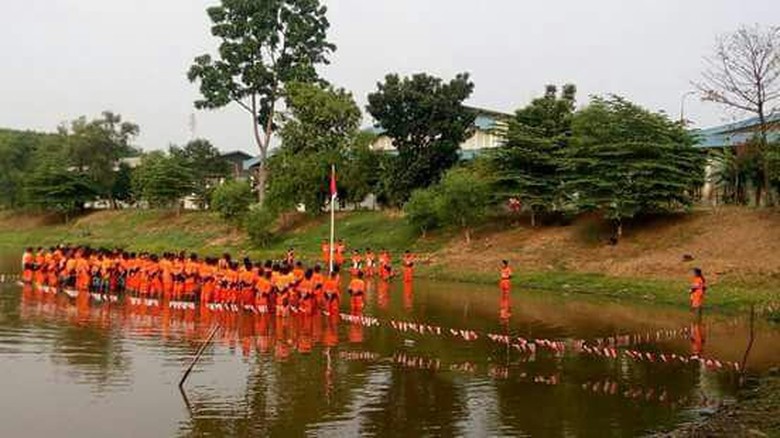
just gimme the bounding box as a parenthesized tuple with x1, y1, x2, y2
(433, 208, 780, 278)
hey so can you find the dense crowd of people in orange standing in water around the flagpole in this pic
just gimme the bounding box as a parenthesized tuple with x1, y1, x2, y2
(22, 240, 414, 316)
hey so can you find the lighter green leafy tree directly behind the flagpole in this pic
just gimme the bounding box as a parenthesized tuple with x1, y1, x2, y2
(268, 83, 360, 214)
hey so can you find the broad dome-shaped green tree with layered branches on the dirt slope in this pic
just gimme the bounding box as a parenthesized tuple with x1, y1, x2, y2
(567, 96, 705, 241)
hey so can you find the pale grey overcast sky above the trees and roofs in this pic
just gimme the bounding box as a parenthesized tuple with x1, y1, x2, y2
(0, 0, 780, 152)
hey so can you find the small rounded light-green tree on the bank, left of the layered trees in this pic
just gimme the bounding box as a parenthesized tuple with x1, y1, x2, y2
(437, 167, 491, 242)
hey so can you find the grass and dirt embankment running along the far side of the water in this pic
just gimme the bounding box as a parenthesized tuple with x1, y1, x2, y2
(0, 209, 780, 311)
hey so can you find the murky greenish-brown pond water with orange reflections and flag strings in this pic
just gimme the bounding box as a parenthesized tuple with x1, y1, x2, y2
(0, 255, 780, 437)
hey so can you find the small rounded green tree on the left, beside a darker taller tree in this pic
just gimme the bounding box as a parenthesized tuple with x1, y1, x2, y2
(133, 151, 192, 208)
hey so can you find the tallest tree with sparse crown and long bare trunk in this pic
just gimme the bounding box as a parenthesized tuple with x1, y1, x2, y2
(187, 0, 336, 203)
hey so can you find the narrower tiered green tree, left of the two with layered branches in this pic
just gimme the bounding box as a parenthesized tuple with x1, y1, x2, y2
(493, 85, 577, 226)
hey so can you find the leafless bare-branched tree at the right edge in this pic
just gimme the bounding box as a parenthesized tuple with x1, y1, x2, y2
(694, 25, 780, 205)
